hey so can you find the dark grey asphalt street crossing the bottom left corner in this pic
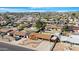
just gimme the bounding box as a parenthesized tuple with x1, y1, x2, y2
(0, 42, 34, 51)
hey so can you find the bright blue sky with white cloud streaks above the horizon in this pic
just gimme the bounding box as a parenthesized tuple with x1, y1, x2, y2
(0, 7, 79, 12)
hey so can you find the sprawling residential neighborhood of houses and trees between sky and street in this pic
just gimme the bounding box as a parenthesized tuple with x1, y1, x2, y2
(0, 12, 79, 51)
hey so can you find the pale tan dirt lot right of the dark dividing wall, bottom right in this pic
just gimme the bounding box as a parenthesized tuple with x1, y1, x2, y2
(53, 43, 79, 51)
